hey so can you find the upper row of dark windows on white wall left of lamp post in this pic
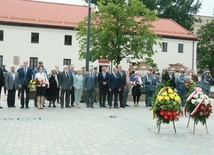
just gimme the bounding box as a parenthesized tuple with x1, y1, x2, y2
(0, 30, 72, 46)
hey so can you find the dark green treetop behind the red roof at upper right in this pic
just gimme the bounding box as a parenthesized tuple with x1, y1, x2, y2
(141, 0, 201, 30)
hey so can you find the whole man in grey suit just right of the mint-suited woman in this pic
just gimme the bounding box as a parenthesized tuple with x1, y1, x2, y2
(83, 66, 98, 108)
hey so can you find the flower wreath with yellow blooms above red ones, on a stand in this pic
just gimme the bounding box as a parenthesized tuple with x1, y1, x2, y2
(152, 86, 181, 125)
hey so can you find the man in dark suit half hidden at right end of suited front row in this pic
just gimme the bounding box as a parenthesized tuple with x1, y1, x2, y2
(117, 64, 129, 108)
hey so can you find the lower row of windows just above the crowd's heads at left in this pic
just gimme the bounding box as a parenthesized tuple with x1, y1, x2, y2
(0, 55, 71, 69)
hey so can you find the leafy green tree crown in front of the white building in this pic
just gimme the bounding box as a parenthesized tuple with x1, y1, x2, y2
(77, 0, 158, 64)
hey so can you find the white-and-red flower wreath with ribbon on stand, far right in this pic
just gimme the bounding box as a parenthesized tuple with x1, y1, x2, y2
(184, 87, 212, 125)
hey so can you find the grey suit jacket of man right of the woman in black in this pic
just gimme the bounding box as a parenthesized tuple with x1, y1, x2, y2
(59, 71, 73, 90)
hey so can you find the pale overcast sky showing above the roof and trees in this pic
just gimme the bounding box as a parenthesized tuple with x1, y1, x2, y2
(38, 0, 214, 16)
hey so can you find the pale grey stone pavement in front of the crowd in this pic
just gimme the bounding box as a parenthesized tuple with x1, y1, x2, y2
(0, 95, 214, 155)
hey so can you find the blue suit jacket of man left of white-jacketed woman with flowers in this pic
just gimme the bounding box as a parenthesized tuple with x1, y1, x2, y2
(18, 67, 33, 85)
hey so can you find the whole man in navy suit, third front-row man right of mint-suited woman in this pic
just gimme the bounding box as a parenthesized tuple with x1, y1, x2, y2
(108, 68, 122, 109)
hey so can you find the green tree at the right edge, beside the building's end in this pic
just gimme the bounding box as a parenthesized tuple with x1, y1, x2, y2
(197, 20, 214, 75)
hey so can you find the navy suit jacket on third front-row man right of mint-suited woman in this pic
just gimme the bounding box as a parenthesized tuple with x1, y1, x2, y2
(108, 73, 122, 90)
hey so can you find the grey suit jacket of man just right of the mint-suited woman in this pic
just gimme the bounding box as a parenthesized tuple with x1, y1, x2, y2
(83, 72, 98, 90)
